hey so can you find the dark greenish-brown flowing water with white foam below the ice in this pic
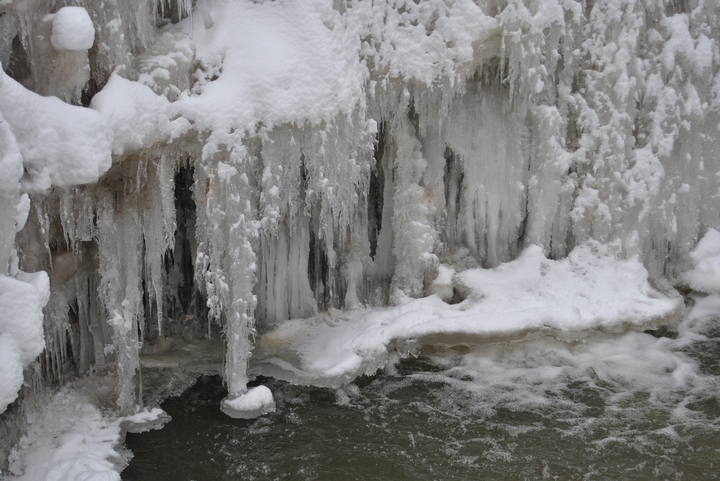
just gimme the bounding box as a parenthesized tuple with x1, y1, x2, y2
(122, 324, 720, 481)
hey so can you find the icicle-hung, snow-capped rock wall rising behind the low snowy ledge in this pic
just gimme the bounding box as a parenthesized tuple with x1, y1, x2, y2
(0, 0, 720, 436)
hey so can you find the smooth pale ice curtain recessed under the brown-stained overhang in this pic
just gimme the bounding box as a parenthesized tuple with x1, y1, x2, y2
(447, 84, 528, 266)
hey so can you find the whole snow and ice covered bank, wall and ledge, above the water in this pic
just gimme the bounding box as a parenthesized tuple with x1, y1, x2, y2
(0, 0, 720, 480)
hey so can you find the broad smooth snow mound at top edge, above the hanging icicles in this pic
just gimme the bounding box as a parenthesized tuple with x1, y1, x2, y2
(177, 0, 366, 142)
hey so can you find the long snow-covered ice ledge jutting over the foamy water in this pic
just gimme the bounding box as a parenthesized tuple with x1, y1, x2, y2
(251, 242, 683, 387)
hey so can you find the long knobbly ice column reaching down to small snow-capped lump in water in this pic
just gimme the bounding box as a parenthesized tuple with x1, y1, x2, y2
(195, 142, 257, 397)
